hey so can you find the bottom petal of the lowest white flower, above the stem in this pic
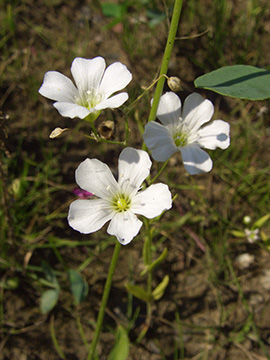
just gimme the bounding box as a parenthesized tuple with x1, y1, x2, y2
(107, 211, 142, 245)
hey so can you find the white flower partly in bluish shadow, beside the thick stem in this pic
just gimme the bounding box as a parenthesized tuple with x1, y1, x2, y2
(143, 92, 230, 175)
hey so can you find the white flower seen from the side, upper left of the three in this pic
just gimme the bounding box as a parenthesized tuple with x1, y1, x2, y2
(39, 57, 132, 120)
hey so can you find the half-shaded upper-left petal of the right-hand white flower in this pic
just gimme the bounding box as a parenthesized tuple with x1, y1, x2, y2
(154, 92, 181, 125)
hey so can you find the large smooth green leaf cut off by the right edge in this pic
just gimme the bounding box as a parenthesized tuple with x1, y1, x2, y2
(194, 65, 270, 100)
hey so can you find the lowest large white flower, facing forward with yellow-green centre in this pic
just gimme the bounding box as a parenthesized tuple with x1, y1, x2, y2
(68, 148, 172, 245)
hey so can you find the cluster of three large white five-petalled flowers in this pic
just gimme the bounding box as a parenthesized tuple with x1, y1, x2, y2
(39, 57, 230, 245)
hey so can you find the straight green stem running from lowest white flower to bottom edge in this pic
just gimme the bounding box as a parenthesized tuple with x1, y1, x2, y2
(87, 241, 121, 360)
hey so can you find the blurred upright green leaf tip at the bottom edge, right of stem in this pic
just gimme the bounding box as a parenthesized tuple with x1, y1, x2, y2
(108, 325, 129, 360)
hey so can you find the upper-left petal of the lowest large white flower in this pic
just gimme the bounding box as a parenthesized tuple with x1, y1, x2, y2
(75, 159, 119, 200)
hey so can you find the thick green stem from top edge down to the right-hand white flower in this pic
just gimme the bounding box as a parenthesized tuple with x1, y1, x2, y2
(148, 0, 183, 121)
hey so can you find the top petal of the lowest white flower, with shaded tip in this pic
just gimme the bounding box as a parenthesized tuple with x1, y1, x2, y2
(118, 147, 152, 194)
